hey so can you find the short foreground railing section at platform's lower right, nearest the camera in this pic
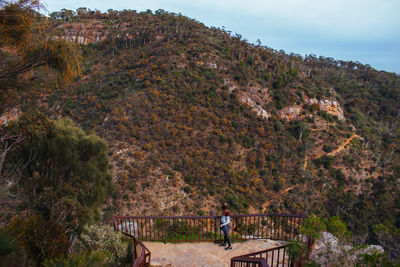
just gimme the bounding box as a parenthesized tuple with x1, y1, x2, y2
(231, 245, 294, 267)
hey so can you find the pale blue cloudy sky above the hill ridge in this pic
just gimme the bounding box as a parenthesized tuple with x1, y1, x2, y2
(43, 0, 400, 74)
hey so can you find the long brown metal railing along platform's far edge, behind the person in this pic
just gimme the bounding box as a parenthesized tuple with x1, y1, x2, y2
(113, 214, 307, 242)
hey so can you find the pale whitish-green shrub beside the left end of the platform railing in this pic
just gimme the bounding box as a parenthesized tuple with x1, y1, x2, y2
(76, 225, 128, 264)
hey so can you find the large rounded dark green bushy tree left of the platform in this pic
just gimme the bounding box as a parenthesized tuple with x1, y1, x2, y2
(7, 113, 111, 232)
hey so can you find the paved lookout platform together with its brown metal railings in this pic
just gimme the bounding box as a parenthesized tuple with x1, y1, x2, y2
(113, 214, 311, 267)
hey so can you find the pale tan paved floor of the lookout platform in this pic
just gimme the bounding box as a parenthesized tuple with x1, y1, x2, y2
(145, 239, 286, 267)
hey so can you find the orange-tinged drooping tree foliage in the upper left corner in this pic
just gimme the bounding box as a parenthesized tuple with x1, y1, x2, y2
(0, 0, 81, 111)
